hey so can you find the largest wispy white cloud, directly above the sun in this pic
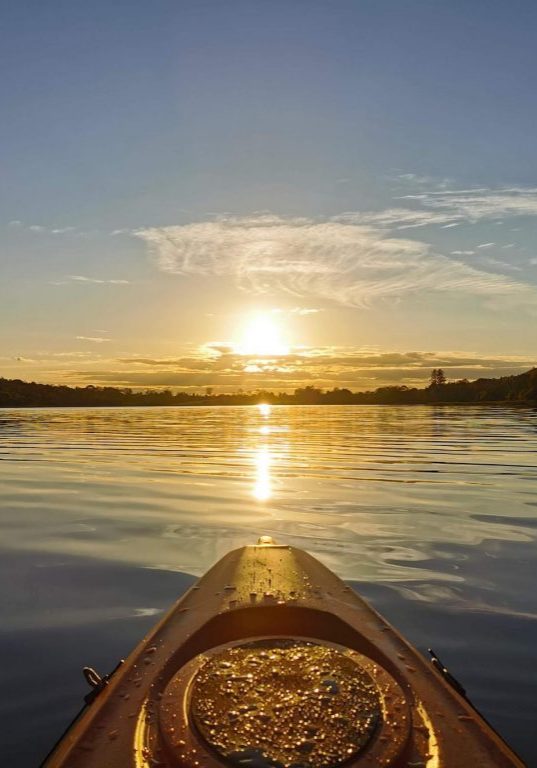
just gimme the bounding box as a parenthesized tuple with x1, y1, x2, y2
(135, 211, 533, 306)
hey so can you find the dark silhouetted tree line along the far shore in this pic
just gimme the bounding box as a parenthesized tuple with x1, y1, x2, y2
(0, 368, 537, 408)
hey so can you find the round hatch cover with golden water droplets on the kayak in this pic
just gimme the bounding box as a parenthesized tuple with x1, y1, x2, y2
(161, 638, 406, 768)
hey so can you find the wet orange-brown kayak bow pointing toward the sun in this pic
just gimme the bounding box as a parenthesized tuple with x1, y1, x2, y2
(43, 537, 524, 768)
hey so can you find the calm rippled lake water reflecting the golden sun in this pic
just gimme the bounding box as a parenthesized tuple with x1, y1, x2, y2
(0, 406, 537, 768)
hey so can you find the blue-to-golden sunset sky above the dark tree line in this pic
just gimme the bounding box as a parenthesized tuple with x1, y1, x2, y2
(0, 0, 537, 391)
